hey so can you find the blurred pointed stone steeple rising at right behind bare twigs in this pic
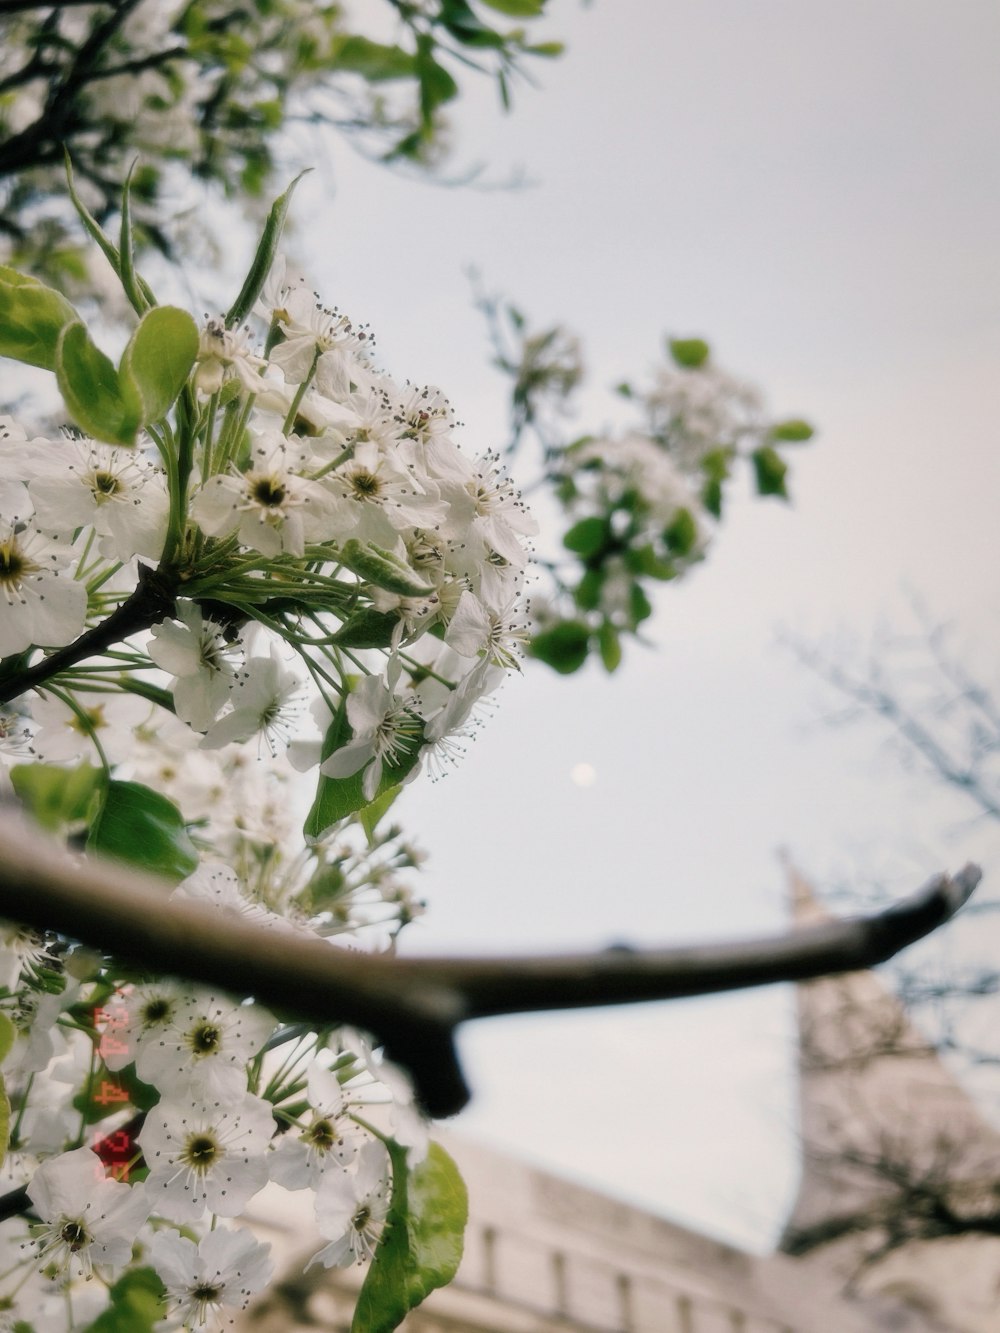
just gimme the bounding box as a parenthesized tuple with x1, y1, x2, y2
(781, 862, 1000, 1253)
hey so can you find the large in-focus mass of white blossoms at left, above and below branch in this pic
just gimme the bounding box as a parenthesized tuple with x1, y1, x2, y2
(0, 226, 525, 1330)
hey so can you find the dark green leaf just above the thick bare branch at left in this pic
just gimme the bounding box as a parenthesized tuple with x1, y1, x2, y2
(87, 778, 197, 884)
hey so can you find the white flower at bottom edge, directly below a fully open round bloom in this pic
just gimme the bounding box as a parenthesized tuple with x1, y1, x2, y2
(149, 1226, 275, 1333)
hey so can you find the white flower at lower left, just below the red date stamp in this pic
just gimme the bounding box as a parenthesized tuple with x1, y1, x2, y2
(28, 1148, 149, 1277)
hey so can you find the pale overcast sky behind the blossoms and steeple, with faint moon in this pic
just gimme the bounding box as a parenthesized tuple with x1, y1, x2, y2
(282, 0, 1000, 1249)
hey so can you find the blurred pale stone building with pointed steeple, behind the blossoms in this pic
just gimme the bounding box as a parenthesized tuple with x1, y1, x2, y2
(241, 874, 1000, 1333)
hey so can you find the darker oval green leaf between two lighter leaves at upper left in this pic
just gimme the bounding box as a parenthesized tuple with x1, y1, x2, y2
(56, 320, 143, 444)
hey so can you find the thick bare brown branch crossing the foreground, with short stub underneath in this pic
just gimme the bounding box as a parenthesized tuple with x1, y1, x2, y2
(0, 812, 980, 1116)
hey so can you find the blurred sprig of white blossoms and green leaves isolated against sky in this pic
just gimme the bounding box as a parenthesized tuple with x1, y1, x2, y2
(477, 302, 813, 674)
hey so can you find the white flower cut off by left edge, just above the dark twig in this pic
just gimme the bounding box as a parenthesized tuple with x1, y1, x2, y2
(0, 519, 87, 657)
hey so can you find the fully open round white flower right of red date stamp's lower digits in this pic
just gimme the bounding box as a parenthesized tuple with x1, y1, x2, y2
(139, 1093, 275, 1222)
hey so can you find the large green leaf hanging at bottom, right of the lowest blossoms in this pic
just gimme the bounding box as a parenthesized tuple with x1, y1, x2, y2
(351, 1144, 468, 1333)
